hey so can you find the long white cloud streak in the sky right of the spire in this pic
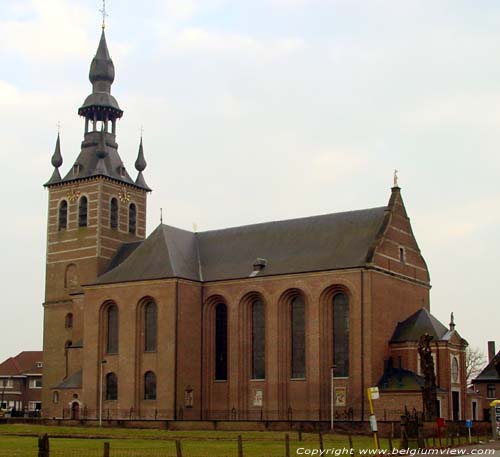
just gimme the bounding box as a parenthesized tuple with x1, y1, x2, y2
(165, 27, 305, 59)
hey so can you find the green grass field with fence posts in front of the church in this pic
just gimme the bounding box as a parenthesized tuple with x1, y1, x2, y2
(0, 425, 390, 457)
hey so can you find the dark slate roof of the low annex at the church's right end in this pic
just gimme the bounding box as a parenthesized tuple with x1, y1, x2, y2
(390, 308, 451, 343)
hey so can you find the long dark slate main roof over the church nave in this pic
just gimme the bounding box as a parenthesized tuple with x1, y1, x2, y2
(94, 207, 387, 284)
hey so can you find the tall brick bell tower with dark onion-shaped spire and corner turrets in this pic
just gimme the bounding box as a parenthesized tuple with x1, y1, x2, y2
(43, 26, 151, 405)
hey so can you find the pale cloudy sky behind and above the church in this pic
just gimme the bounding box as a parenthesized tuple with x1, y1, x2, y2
(0, 0, 500, 360)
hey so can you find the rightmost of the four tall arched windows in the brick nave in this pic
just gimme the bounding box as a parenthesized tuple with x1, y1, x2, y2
(333, 293, 349, 377)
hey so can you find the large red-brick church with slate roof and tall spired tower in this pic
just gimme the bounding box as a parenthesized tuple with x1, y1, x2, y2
(43, 30, 478, 420)
